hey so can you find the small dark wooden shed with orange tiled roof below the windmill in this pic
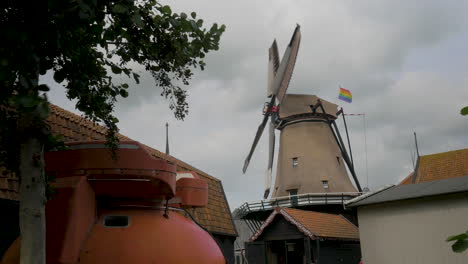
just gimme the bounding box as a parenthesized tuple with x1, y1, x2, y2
(246, 207, 361, 264)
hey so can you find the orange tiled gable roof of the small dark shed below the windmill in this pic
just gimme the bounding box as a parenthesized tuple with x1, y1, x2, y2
(251, 208, 359, 241)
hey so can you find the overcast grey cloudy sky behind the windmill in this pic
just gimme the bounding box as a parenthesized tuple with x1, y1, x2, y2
(43, 0, 468, 210)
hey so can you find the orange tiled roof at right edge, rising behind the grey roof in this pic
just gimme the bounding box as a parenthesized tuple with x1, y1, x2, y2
(400, 149, 468, 184)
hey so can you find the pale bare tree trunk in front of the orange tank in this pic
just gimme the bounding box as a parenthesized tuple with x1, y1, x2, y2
(20, 137, 46, 264)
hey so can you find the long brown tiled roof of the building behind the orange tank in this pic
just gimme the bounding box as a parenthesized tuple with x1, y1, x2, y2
(0, 105, 237, 235)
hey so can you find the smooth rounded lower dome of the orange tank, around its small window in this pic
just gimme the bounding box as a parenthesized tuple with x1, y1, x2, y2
(79, 209, 225, 264)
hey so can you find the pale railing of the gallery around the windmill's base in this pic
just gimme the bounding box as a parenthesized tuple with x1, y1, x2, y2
(234, 192, 362, 218)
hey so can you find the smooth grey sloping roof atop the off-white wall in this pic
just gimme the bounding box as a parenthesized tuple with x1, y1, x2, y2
(346, 176, 468, 207)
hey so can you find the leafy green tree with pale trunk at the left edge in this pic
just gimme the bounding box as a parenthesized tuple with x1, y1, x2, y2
(0, 0, 225, 263)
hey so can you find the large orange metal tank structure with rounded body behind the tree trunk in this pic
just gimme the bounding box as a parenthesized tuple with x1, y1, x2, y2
(1, 141, 225, 264)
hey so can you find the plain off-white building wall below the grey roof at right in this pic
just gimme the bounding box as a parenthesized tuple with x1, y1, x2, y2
(358, 193, 468, 264)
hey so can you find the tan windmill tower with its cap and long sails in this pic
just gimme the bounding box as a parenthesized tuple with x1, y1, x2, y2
(243, 25, 361, 199)
